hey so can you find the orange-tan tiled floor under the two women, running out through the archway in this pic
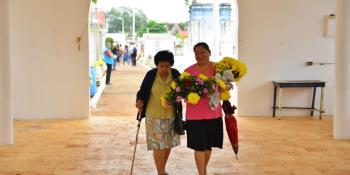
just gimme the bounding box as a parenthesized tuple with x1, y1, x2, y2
(0, 67, 350, 175)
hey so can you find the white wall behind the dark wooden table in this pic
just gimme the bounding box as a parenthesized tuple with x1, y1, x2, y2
(238, 0, 335, 116)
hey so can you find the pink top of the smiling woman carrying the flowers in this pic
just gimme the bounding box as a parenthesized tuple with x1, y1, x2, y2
(185, 64, 222, 120)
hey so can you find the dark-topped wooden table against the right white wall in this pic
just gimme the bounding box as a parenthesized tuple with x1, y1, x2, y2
(272, 80, 326, 119)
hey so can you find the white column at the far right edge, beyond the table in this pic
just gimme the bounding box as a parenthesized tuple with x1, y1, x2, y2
(333, 0, 350, 140)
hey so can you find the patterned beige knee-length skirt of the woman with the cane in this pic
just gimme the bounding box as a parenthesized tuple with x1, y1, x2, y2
(146, 117, 180, 150)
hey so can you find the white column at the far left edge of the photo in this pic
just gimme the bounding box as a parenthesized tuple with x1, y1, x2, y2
(0, 0, 13, 145)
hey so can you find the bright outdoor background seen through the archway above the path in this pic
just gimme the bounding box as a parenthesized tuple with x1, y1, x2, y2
(89, 0, 238, 110)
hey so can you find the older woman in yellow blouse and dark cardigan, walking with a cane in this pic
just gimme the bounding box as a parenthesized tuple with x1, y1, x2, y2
(136, 50, 180, 175)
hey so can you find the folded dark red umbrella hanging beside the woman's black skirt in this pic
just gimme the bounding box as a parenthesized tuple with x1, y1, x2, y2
(222, 100, 238, 159)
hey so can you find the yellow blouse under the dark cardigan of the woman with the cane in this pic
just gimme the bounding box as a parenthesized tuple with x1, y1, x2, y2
(146, 72, 174, 119)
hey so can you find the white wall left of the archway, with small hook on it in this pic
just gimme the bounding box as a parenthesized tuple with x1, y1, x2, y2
(10, 0, 89, 119)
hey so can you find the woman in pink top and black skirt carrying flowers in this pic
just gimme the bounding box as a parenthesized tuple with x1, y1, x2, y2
(185, 42, 223, 175)
